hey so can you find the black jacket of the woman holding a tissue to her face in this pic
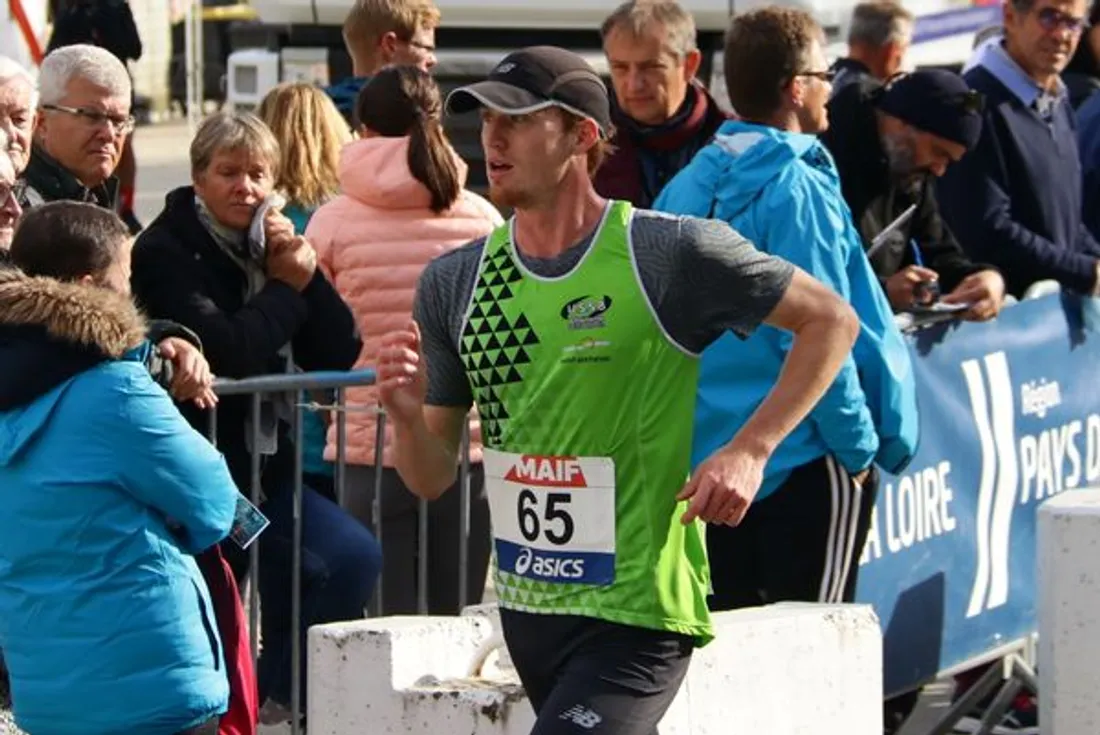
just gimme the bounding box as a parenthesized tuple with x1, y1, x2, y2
(131, 187, 363, 495)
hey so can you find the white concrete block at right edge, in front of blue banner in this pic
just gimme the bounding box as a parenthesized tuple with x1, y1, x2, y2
(1037, 490, 1100, 735)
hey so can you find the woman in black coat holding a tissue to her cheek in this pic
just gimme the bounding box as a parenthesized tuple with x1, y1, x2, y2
(131, 113, 381, 716)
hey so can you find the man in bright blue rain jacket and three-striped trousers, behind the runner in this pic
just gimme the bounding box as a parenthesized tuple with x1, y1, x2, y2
(655, 8, 917, 610)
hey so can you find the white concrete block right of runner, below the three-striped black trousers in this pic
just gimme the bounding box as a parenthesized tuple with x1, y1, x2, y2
(661, 604, 882, 735)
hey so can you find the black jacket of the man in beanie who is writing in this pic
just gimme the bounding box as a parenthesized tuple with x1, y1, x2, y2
(821, 77, 991, 293)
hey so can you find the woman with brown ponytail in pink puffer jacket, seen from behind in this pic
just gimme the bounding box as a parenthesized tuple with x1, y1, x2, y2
(306, 67, 502, 615)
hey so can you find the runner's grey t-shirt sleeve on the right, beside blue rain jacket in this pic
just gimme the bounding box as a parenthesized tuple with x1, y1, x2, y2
(631, 211, 794, 353)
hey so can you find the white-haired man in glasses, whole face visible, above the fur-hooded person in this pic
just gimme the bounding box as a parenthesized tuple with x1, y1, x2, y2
(22, 44, 134, 215)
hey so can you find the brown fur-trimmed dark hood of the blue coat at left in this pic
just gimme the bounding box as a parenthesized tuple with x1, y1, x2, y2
(0, 268, 145, 412)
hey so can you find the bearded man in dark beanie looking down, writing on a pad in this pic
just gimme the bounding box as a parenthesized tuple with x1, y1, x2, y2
(822, 69, 1004, 320)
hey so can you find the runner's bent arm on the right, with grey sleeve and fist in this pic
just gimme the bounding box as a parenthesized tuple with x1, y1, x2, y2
(634, 218, 859, 526)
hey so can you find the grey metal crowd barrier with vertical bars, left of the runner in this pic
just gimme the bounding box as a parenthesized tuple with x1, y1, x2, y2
(208, 370, 471, 735)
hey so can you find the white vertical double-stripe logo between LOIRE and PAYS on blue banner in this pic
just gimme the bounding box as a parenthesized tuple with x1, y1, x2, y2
(963, 352, 1020, 617)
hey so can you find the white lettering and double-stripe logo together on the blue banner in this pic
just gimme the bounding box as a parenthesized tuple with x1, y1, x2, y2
(859, 352, 1100, 572)
